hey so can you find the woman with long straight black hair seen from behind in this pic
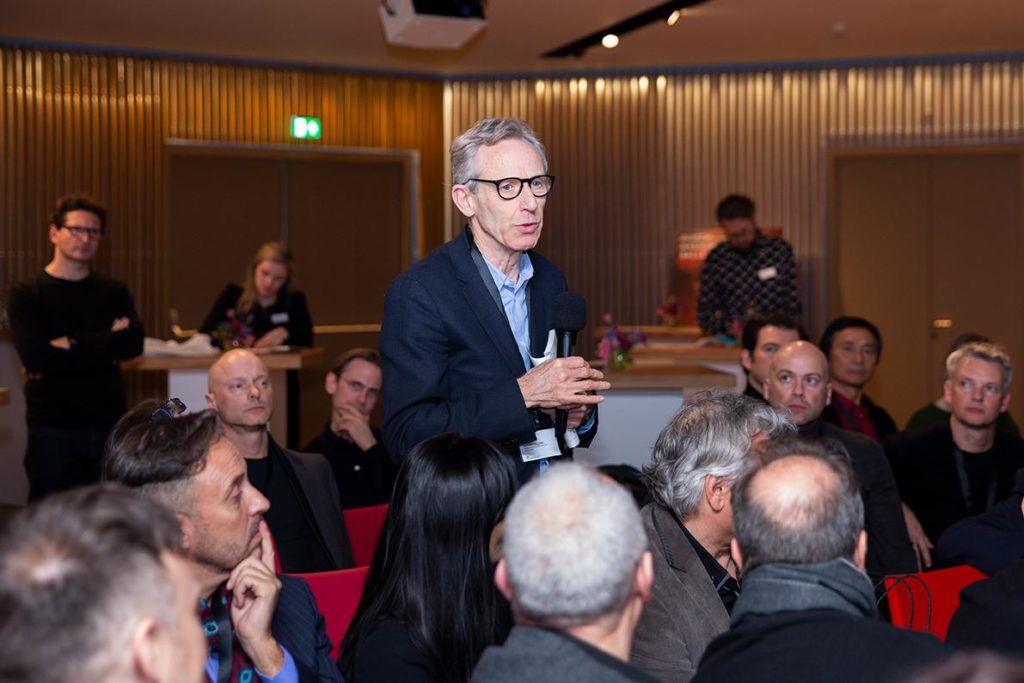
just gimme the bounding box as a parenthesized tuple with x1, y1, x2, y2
(338, 434, 516, 683)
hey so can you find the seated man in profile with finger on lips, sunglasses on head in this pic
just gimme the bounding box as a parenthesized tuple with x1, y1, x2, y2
(103, 401, 341, 683)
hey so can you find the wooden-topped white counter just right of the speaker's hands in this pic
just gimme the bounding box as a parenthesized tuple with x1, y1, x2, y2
(575, 365, 736, 469)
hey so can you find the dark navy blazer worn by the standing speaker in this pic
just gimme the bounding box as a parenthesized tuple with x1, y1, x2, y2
(380, 227, 597, 466)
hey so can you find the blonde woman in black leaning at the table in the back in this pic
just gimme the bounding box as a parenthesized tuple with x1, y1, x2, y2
(199, 242, 313, 348)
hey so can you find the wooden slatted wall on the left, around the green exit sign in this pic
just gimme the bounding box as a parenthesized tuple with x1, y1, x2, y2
(0, 46, 447, 405)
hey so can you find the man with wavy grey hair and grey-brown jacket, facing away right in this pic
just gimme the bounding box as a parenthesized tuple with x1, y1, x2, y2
(633, 391, 793, 682)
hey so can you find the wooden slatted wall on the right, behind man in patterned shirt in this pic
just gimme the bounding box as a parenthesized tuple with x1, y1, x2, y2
(447, 61, 1024, 344)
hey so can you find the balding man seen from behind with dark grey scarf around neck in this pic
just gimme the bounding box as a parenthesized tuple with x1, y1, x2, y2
(693, 438, 948, 683)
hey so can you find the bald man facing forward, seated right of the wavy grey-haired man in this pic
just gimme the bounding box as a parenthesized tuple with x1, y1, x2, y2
(764, 341, 918, 582)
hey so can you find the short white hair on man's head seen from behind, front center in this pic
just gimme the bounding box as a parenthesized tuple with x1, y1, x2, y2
(504, 463, 647, 628)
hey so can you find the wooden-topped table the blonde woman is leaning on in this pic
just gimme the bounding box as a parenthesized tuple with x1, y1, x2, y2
(121, 348, 326, 445)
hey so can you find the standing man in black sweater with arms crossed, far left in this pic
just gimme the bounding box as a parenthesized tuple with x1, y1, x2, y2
(7, 195, 142, 502)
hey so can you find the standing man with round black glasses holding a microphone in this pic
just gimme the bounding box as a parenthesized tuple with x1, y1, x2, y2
(380, 119, 608, 476)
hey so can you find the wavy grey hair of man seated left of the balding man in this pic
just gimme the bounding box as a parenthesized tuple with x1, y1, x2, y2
(643, 390, 795, 519)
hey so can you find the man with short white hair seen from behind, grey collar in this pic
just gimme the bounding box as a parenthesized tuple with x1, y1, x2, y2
(473, 463, 653, 683)
